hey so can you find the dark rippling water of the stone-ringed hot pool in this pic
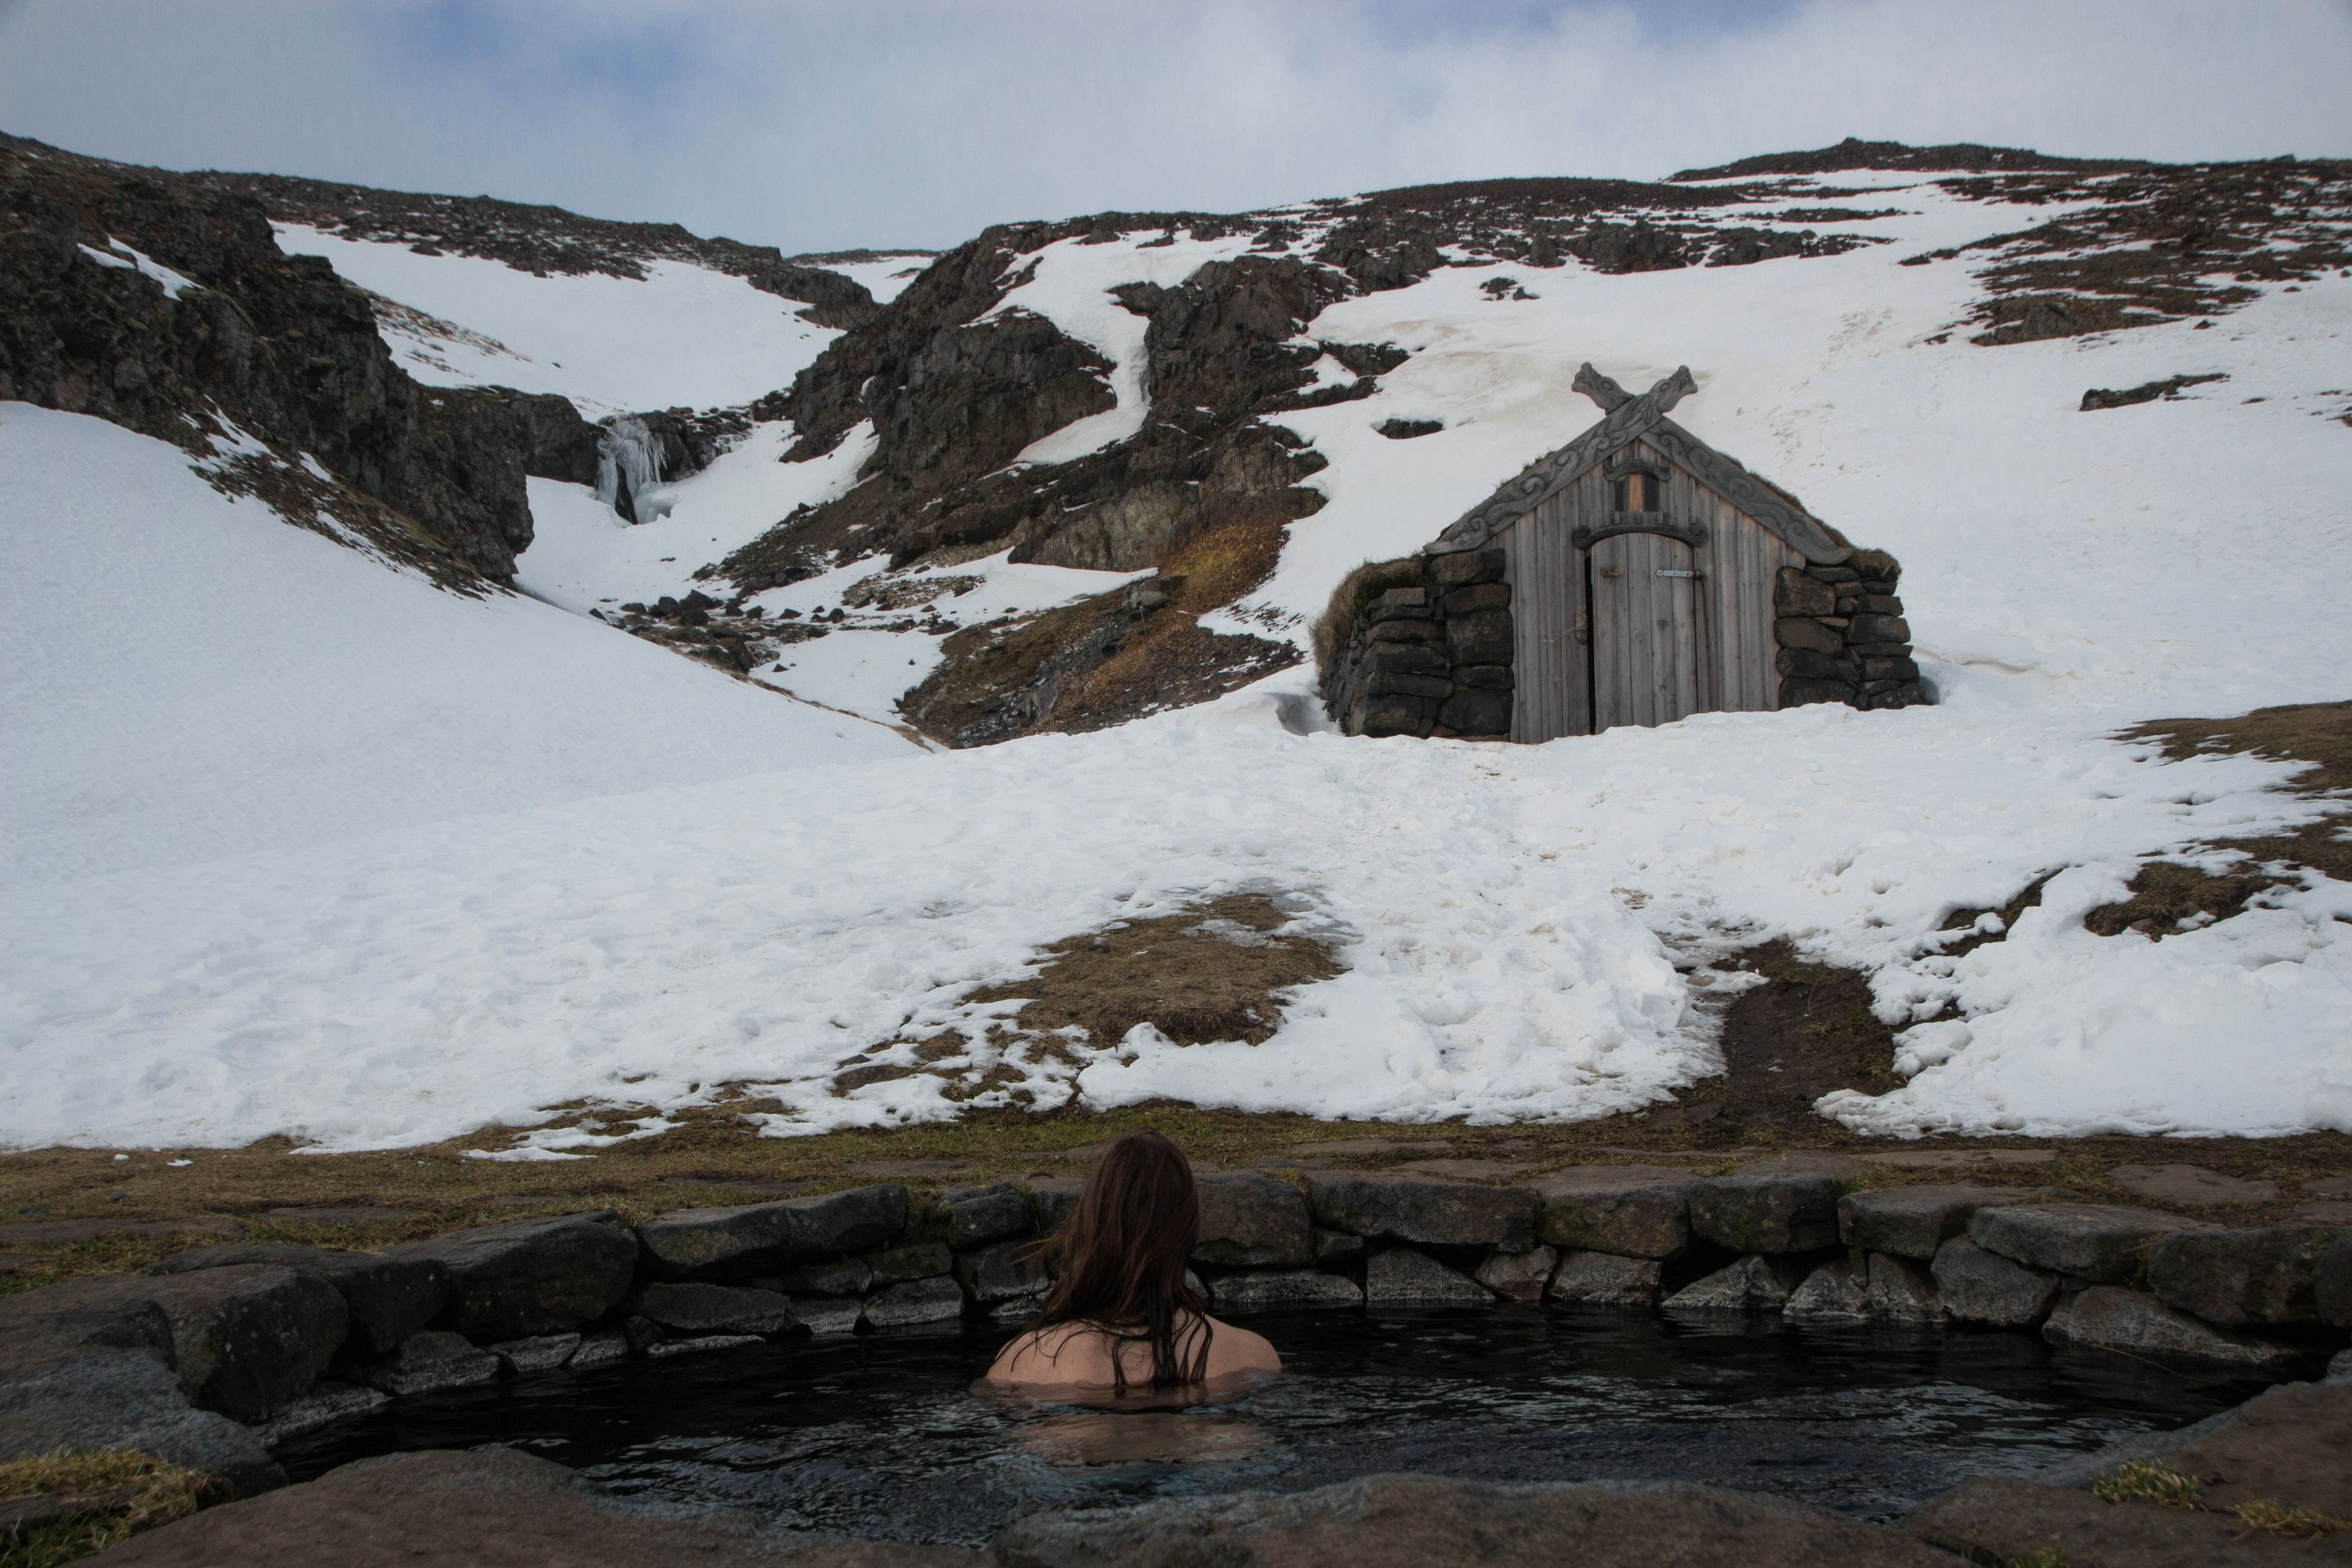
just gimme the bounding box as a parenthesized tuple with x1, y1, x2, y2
(277, 1307, 2263, 1542)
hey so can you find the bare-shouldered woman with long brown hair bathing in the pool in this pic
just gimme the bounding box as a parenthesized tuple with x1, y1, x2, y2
(988, 1133, 1282, 1394)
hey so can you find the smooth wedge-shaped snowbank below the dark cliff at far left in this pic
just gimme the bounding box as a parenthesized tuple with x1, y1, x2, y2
(0, 402, 913, 893)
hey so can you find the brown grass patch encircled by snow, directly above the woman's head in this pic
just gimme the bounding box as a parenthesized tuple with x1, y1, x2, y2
(969, 893, 1338, 1046)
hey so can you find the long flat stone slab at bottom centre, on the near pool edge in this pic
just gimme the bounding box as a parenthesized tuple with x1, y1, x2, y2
(992, 1476, 1952, 1568)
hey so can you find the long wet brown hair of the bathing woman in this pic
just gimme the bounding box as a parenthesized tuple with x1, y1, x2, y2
(1037, 1133, 1209, 1394)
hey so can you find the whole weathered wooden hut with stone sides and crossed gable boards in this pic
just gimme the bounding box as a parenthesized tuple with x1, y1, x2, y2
(1317, 364, 1926, 741)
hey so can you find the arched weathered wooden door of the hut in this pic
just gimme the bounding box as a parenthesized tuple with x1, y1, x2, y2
(1585, 533, 1714, 733)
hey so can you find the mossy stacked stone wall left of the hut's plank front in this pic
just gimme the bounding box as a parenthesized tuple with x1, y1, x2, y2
(1322, 550, 1512, 741)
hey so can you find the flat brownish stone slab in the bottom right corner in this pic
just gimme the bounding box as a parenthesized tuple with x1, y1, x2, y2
(1903, 1476, 2305, 1568)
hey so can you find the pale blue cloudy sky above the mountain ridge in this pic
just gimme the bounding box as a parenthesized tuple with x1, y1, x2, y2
(0, 0, 2352, 252)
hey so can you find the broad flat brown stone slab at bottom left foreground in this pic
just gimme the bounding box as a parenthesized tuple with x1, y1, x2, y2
(92, 1448, 981, 1568)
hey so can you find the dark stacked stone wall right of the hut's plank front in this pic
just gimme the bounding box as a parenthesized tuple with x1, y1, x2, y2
(1771, 550, 1926, 707)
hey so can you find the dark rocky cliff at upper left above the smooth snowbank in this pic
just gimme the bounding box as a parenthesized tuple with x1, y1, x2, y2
(0, 137, 532, 583)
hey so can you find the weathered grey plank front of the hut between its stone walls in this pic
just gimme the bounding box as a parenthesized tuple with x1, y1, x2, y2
(1496, 442, 1804, 741)
